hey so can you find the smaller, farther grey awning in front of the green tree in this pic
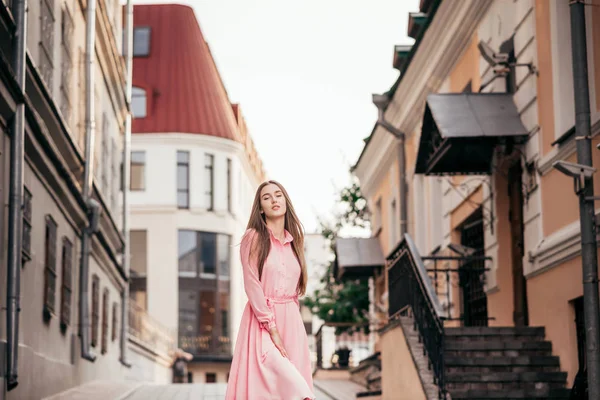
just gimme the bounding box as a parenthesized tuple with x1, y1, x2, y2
(334, 238, 385, 280)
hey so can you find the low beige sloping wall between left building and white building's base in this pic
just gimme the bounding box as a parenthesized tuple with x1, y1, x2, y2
(129, 299, 175, 358)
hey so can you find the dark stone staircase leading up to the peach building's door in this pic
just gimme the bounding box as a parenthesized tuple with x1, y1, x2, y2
(444, 327, 569, 400)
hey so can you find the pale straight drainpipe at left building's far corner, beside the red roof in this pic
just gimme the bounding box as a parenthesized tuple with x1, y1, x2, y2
(121, 0, 133, 367)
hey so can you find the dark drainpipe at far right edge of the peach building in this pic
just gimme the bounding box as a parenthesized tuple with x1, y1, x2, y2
(569, 0, 600, 399)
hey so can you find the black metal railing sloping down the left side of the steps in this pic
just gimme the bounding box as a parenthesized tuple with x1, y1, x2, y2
(386, 234, 446, 399)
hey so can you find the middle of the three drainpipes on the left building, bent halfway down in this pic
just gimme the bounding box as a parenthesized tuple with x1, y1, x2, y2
(79, 0, 98, 362)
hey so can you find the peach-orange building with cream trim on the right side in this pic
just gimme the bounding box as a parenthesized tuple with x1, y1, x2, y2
(341, 0, 600, 399)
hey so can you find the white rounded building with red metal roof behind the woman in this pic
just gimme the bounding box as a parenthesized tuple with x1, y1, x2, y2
(130, 5, 264, 383)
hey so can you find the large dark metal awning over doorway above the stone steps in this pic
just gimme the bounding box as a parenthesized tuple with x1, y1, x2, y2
(415, 93, 528, 175)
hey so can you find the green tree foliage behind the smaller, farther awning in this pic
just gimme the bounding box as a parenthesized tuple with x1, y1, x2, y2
(304, 180, 369, 333)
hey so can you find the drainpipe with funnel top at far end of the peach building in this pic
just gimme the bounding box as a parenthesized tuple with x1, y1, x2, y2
(373, 94, 408, 240)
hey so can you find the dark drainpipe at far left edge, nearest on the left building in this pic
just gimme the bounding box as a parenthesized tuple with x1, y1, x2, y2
(6, 0, 27, 390)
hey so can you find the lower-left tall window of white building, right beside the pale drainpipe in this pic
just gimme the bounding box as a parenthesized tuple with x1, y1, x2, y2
(129, 230, 148, 310)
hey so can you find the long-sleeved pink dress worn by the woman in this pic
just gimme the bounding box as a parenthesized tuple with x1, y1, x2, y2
(225, 230, 315, 400)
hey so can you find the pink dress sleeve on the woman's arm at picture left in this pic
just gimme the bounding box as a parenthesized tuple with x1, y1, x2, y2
(240, 230, 275, 330)
